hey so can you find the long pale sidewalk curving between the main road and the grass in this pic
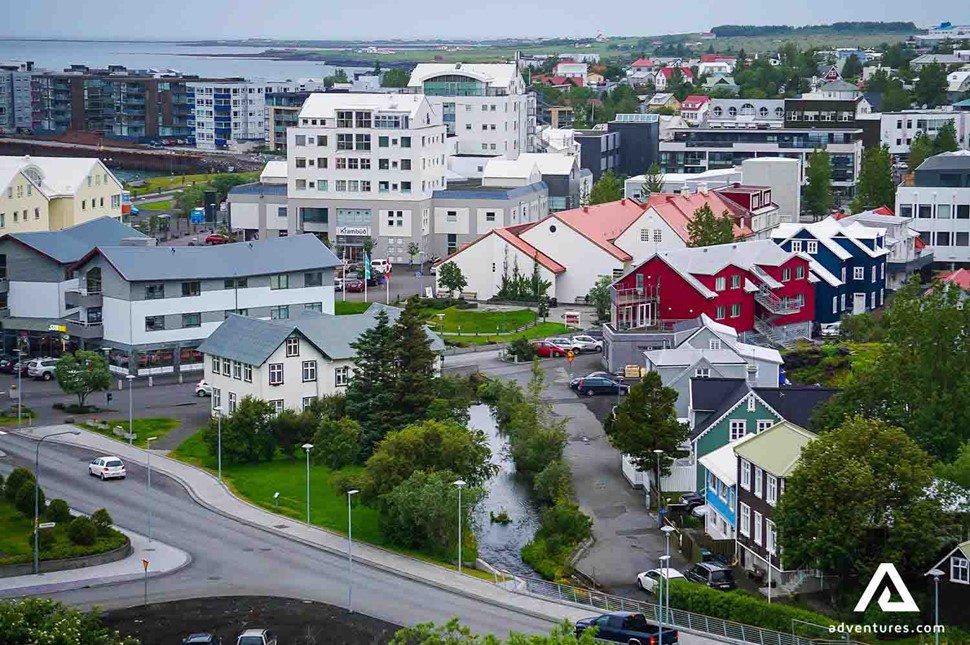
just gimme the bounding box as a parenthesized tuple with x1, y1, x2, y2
(7, 426, 608, 621)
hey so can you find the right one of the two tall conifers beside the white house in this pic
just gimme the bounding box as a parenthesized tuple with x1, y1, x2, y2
(388, 298, 436, 428)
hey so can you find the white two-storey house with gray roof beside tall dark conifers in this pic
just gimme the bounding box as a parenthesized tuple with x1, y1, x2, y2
(199, 304, 445, 415)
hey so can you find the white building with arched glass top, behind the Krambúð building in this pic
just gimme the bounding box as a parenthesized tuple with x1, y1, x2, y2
(408, 63, 532, 159)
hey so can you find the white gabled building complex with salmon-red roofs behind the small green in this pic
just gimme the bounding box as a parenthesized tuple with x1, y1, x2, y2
(438, 191, 752, 303)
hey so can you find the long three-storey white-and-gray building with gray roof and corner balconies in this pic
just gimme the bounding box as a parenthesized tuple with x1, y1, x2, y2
(73, 235, 339, 375)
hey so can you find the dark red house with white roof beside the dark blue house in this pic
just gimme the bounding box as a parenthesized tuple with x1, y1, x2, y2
(612, 240, 817, 344)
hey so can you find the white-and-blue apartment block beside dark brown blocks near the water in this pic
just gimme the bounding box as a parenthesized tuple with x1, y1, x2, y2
(187, 79, 325, 150)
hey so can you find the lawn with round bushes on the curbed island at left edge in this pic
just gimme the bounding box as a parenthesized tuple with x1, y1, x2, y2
(0, 496, 127, 565)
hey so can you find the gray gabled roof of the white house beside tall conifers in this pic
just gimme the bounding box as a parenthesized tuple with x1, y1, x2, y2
(199, 303, 445, 366)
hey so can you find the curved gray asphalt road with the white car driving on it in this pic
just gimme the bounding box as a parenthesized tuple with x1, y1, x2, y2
(0, 434, 552, 634)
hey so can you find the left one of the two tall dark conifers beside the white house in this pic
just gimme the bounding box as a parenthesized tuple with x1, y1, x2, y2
(346, 309, 397, 454)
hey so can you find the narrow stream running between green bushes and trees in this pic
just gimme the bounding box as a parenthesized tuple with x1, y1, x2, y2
(469, 405, 539, 575)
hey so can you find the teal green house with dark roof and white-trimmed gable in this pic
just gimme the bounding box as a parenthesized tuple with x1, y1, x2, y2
(688, 377, 838, 491)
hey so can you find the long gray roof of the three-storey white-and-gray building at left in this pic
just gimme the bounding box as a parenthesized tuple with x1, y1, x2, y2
(88, 233, 340, 282)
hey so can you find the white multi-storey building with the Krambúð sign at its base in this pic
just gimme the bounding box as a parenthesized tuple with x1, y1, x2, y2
(286, 93, 446, 259)
